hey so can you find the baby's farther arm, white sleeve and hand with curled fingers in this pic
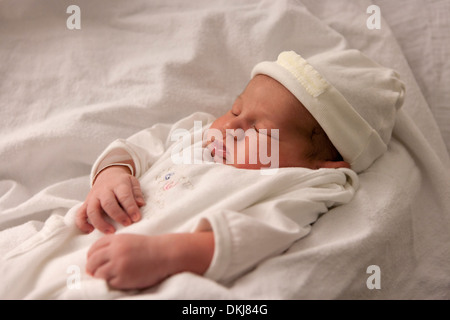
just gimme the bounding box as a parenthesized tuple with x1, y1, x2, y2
(76, 113, 214, 233)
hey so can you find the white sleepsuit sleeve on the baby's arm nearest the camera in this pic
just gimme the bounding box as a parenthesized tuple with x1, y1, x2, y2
(196, 169, 358, 282)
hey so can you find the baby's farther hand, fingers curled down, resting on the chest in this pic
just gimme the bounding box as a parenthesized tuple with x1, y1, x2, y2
(75, 166, 145, 233)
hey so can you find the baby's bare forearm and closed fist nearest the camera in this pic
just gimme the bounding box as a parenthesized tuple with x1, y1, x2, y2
(86, 231, 214, 289)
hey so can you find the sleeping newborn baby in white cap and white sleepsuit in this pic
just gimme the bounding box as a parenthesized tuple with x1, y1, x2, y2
(0, 50, 404, 299)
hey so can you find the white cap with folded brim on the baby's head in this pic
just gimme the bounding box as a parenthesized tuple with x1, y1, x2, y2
(251, 50, 405, 172)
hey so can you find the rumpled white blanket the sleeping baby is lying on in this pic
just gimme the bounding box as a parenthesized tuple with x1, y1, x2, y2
(0, 0, 450, 299)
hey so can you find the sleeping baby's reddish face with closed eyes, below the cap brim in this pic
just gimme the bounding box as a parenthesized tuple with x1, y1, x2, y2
(207, 75, 326, 169)
